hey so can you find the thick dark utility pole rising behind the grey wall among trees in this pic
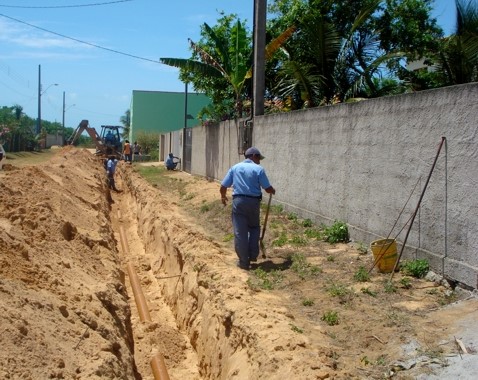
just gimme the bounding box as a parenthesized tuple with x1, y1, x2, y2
(252, 0, 267, 116)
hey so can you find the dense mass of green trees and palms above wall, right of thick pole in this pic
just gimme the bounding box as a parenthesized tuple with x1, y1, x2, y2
(268, 0, 442, 109)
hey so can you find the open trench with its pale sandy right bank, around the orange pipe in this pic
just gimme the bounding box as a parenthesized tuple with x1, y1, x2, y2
(111, 166, 324, 379)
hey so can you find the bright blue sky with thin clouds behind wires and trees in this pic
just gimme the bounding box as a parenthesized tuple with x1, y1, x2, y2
(0, 0, 455, 127)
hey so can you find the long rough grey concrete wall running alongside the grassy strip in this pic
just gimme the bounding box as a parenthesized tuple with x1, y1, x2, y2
(192, 83, 478, 288)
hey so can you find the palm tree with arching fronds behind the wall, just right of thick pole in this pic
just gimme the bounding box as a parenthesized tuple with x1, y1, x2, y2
(276, 0, 390, 107)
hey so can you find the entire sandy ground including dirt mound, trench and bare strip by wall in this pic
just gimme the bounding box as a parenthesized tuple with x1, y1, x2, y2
(0, 149, 478, 380)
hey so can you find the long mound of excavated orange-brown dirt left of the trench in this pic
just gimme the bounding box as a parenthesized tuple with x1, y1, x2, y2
(0, 150, 135, 379)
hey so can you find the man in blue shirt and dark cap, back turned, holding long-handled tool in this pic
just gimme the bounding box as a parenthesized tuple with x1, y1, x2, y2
(219, 147, 276, 270)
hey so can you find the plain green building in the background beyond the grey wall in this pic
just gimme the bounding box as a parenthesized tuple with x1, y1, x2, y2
(131, 90, 211, 134)
